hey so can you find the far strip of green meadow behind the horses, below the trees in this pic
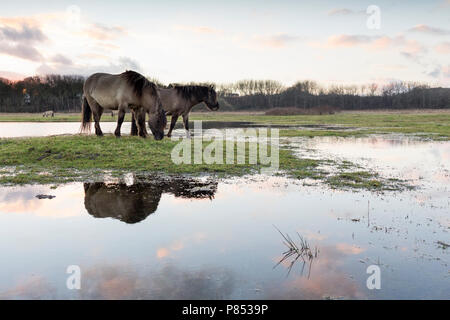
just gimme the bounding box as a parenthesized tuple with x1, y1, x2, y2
(0, 110, 450, 140)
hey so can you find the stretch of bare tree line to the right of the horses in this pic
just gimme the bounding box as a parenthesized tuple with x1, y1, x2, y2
(218, 80, 450, 110)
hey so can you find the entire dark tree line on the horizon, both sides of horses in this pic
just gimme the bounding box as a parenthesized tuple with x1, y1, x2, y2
(0, 75, 450, 112)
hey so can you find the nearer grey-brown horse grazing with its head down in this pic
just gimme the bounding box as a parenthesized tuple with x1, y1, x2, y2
(81, 71, 167, 140)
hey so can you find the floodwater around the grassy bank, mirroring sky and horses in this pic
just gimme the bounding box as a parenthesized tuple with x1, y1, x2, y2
(0, 123, 450, 299)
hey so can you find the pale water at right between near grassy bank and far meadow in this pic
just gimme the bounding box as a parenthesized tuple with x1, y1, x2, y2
(285, 135, 450, 191)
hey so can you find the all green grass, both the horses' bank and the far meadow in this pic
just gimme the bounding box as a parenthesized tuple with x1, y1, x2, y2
(0, 112, 436, 190)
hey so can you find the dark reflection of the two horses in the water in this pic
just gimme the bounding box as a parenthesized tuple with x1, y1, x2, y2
(84, 179, 217, 223)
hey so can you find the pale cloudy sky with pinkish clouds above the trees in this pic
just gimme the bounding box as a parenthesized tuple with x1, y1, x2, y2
(0, 0, 450, 87)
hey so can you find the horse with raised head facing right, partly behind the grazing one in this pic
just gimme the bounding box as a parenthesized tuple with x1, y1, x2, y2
(131, 84, 219, 137)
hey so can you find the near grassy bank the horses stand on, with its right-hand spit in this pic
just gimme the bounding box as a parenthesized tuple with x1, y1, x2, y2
(0, 135, 404, 190)
